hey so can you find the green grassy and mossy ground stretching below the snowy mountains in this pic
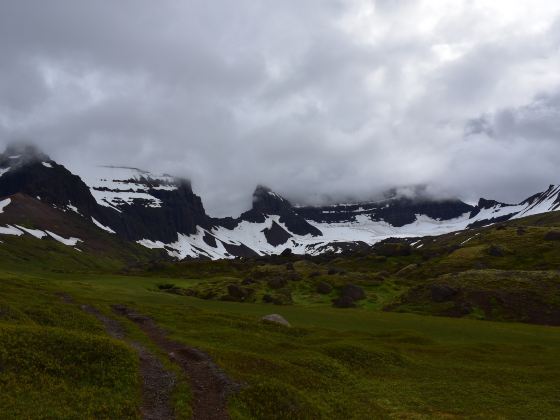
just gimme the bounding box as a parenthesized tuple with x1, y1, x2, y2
(0, 210, 560, 419)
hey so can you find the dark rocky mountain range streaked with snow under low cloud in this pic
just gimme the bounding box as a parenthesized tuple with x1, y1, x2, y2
(0, 145, 560, 259)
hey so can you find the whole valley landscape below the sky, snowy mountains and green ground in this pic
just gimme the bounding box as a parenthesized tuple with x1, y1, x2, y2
(0, 144, 560, 419)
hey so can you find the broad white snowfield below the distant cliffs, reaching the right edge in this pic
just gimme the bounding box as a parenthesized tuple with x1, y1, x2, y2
(135, 186, 560, 259)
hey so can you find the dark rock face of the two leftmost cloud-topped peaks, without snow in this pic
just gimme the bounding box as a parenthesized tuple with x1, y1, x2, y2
(0, 146, 213, 243)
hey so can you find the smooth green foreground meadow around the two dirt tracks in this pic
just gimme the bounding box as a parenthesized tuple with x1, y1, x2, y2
(0, 264, 560, 419)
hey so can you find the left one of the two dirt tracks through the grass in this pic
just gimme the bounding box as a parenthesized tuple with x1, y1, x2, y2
(58, 293, 175, 420)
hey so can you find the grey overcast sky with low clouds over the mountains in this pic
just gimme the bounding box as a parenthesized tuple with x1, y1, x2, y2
(0, 0, 560, 215)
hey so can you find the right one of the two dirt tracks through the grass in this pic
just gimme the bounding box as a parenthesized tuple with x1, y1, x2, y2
(113, 305, 239, 420)
